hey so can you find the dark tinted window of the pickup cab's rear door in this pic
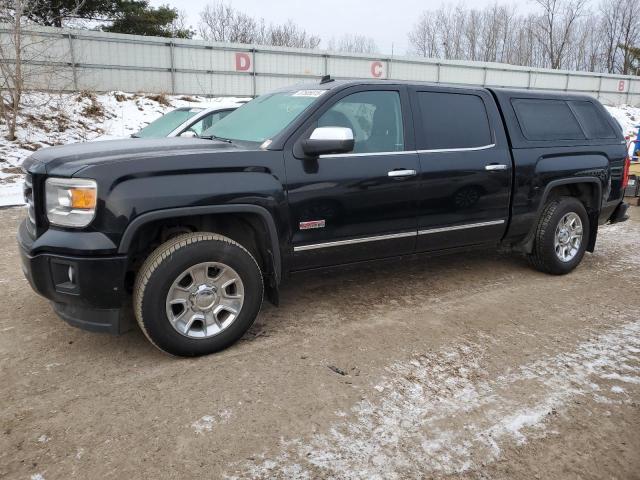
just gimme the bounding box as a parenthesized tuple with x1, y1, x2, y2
(416, 92, 493, 150)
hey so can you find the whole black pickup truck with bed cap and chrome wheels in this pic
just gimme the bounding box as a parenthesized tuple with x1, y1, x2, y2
(18, 78, 629, 356)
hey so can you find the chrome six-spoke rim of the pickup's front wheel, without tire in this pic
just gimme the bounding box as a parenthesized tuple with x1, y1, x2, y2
(166, 262, 244, 338)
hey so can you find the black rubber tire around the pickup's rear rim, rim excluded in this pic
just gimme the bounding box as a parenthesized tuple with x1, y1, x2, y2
(528, 197, 590, 275)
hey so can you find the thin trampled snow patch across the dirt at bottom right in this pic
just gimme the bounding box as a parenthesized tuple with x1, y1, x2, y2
(232, 315, 640, 479)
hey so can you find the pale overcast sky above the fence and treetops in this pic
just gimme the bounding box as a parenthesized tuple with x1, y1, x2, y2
(151, 0, 533, 55)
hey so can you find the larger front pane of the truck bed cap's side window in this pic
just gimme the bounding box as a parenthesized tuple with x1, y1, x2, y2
(511, 98, 585, 140)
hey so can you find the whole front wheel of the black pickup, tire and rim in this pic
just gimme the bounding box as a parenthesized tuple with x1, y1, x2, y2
(133, 232, 264, 356)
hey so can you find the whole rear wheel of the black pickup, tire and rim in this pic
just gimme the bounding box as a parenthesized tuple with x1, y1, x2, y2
(528, 197, 589, 275)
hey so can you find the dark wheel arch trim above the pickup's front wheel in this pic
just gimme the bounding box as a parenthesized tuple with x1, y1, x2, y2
(118, 204, 282, 283)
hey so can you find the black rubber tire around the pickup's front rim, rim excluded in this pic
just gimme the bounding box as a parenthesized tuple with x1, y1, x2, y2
(133, 232, 264, 357)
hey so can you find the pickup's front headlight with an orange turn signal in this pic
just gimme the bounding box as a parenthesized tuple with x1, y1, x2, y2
(45, 178, 98, 228)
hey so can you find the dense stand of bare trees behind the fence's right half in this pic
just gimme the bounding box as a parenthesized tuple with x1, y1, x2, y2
(408, 0, 640, 73)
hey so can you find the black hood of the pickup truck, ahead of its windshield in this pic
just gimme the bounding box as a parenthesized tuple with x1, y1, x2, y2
(23, 138, 238, 176)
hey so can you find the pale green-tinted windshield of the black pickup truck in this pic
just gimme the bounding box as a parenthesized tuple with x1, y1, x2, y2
(202, 90, 325, 143)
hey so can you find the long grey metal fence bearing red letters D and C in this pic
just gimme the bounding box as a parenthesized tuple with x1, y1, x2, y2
(0, 24, 640, 105)
